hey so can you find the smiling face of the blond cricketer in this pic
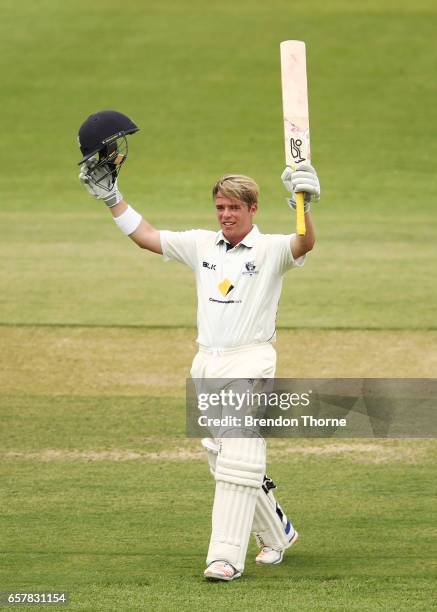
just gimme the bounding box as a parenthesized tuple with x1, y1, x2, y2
(215, 191, 258, 245)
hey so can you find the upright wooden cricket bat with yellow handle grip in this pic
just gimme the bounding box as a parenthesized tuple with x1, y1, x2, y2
(280, 40, 311, 236)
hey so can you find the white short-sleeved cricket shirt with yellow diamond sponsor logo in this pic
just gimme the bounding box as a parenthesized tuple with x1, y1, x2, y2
(160, 225, 305, 348)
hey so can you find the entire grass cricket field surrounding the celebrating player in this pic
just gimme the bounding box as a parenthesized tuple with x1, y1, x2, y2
(0, 0, 437, 612)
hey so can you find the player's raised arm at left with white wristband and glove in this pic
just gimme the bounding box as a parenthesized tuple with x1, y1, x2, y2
(79, 160, 162, 254)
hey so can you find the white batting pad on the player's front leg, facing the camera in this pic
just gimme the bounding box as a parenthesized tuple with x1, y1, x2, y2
(206, 438, 266, 571)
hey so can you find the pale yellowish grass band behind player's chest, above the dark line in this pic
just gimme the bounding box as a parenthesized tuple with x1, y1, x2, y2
(0, 209, 437, 329)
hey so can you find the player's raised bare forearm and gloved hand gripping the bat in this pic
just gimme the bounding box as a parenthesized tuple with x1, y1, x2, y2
(281, 161, 320, 259)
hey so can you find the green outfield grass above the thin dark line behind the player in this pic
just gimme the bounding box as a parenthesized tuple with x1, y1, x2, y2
(0, 0, 437, 329)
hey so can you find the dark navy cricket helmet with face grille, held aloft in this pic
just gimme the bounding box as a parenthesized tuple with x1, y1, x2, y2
(77, 110, 140, 187)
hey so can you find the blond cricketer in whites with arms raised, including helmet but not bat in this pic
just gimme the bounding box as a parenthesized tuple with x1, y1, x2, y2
(78, 111, 320, 581)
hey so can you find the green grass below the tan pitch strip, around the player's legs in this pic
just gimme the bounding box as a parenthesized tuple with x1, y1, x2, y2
(0, 388, 435, 610)
